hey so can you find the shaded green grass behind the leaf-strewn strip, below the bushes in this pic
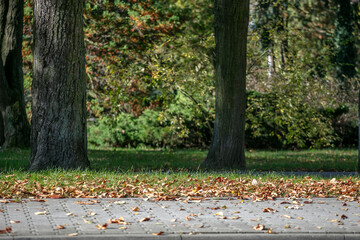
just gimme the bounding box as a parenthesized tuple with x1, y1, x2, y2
(0, 146, 357, 172)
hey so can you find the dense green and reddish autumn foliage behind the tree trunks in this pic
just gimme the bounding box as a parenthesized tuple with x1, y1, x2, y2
(23, 0, 359, 148)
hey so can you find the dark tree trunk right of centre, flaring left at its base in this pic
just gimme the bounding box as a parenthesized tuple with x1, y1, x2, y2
(202, 0, 249, 168)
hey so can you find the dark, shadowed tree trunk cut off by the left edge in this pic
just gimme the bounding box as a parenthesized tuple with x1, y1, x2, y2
(0, 0, 30, 147)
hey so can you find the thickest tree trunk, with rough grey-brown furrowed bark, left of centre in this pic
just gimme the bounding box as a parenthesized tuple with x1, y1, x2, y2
(29, 0, 89, 170)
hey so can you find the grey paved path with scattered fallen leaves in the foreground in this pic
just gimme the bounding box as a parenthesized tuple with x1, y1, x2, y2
(0, 198, 360, 240)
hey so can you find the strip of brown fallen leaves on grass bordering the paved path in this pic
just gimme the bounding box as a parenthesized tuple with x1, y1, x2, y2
(0, 174, 360, 200)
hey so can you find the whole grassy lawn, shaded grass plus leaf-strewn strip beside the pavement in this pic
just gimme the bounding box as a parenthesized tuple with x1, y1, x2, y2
(0, 149, 360, 200)
